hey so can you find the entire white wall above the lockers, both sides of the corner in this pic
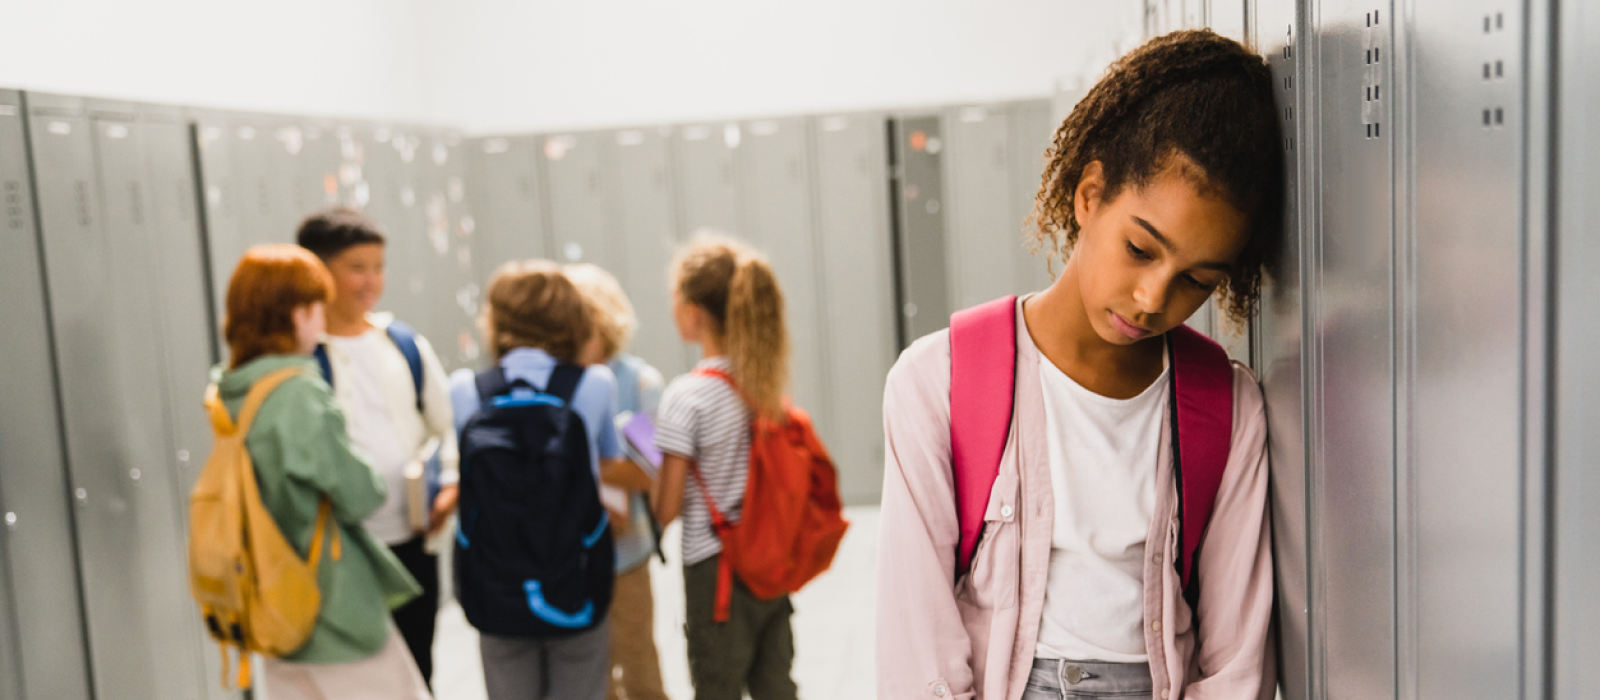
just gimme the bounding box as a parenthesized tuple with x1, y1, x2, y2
(0, 0, 1142, 133)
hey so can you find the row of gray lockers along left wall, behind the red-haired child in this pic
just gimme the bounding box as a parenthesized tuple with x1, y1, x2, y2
(0, 91, 478, 700)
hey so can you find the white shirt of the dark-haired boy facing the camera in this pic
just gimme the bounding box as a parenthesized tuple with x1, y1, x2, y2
(328, 328, 416, 545)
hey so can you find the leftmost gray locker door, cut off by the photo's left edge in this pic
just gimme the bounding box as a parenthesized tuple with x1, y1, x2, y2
(0, 89, 90, 700)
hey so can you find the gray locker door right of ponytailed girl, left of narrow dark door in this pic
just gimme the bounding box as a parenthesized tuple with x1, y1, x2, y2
(811, 113, 898, 505)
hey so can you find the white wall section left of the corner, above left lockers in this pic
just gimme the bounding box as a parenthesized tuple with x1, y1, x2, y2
(0, 0, 430, 120)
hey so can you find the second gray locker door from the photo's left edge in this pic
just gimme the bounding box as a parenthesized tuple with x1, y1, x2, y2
(30, 94, 202, 698)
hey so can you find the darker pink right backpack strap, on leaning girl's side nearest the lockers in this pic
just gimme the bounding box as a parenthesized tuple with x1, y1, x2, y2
(1166, 326, 1234, 590)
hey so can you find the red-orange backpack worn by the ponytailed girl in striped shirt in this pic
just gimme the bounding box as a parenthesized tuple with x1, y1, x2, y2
(693, 369, 850, 622)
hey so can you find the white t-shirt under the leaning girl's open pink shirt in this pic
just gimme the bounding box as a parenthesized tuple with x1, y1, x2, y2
(1034, 350, 1171, 663)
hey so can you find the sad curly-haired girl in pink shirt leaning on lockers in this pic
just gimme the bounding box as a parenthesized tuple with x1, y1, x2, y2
(877, 30, 1283, 700)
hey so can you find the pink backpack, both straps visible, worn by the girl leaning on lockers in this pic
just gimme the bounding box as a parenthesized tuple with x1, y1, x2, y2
(950, 296, 1234, 595)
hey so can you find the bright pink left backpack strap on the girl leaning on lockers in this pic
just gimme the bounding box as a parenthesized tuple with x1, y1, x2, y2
(950, 296, 1016, 574)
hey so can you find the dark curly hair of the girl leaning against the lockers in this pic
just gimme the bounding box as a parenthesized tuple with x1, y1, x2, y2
(1029, 30, 1285, 321)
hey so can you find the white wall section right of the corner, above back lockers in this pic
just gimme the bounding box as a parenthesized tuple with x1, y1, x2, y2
(424, 0, 1142, 133)
